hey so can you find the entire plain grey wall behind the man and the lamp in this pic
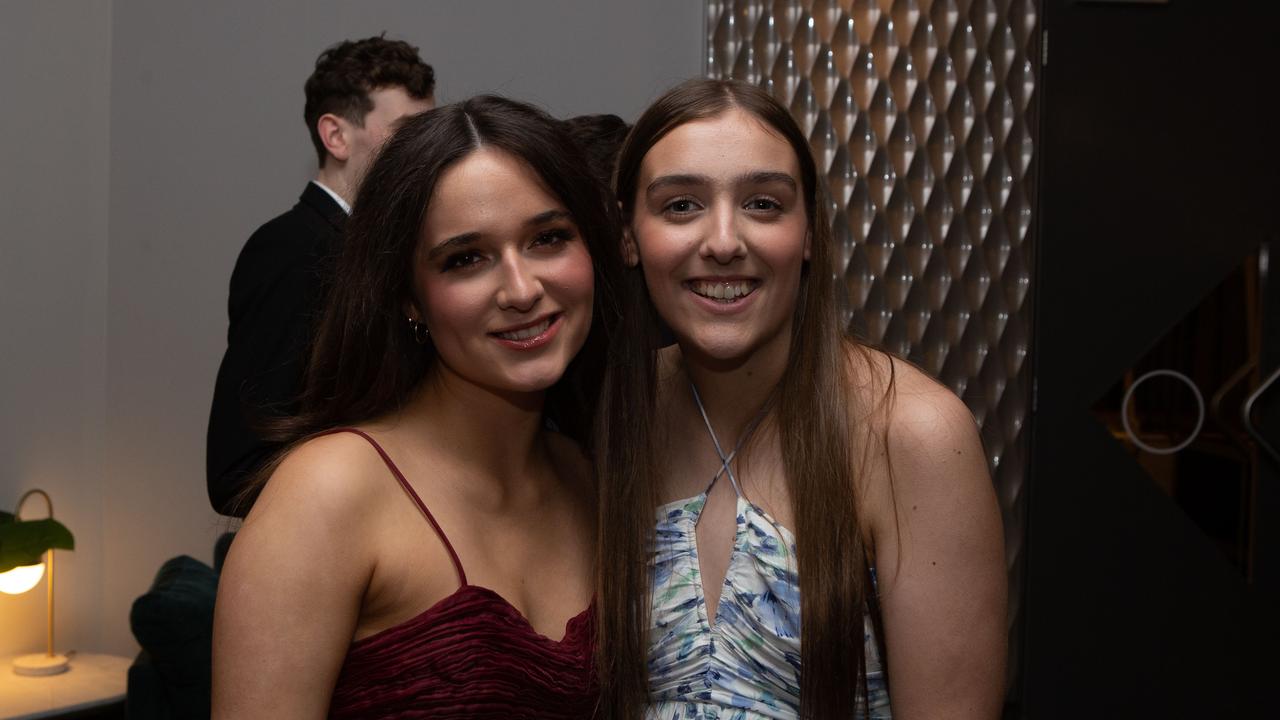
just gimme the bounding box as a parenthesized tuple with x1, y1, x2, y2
(0, 0, 703, 653)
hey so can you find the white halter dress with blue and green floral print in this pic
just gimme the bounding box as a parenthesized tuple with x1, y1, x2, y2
(648, 388, 891, 720)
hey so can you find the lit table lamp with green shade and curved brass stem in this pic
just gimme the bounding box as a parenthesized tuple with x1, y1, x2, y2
(0, 489, 76, 675)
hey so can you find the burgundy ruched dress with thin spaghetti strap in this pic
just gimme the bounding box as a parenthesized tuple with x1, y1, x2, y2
(329, 428, 599, 720)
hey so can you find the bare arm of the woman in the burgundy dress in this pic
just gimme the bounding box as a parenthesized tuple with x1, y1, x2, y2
(212, 436, 372, 720)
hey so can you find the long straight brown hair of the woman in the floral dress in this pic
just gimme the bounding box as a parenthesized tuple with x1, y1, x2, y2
(595, 79, 873, 720)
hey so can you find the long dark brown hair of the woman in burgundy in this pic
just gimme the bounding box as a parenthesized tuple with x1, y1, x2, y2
(243, 96, 622, 499)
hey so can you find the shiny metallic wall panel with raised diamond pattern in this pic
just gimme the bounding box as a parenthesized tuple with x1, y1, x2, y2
(707, 0, 1039, 688)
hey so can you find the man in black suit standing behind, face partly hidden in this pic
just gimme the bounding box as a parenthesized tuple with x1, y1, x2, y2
(205, 36, 435, 516)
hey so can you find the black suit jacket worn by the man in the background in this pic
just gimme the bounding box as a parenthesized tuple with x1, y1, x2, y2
(205, 183, 347, 516)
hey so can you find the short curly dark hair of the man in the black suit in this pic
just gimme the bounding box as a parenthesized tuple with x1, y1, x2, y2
(302, 33, 435, 168)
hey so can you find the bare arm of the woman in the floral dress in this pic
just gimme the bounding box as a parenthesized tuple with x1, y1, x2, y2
(869, 363, 1007, 720)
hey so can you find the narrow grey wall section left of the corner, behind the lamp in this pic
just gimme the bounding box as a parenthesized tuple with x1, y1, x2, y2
(0, 0, 111, 655)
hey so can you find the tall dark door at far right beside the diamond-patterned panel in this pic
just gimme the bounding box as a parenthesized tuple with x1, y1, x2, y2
(1010, 0, 1280, 720)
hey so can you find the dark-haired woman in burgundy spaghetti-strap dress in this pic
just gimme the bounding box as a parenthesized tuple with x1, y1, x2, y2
(212, 97, 621, 720)
